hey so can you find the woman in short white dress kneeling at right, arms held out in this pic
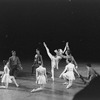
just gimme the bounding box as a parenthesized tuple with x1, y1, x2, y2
(59, 59, 80, 89)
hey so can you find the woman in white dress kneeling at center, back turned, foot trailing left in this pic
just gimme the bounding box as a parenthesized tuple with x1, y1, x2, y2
(31, 63, 47, 92)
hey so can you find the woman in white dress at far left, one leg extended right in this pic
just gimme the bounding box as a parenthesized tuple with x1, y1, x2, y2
(1, 62, 19, 88)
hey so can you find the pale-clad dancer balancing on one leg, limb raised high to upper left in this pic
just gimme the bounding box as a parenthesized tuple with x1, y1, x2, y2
(43, 42, 62, 81)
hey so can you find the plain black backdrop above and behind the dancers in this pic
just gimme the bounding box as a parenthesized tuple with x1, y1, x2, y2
(0, 0, 100, 61)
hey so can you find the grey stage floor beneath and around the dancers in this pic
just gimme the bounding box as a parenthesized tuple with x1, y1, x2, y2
(0, 62, 100, 100)
